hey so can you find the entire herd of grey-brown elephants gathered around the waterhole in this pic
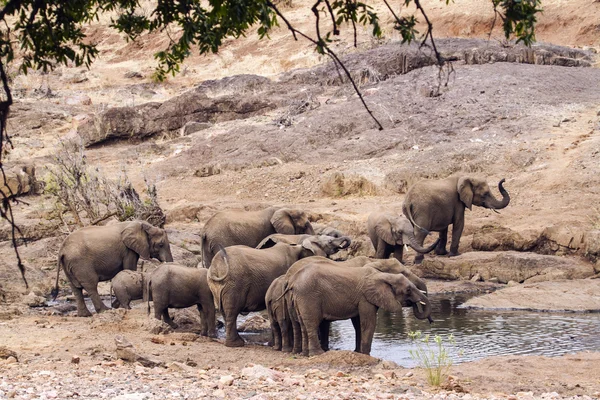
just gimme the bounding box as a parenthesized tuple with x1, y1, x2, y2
(53, 176, 510, 356)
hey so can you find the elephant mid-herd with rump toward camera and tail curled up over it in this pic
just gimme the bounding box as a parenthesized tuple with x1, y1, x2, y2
(208, 236, 351, 347)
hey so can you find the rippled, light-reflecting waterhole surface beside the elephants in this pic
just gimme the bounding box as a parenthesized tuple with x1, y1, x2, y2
(331, 295, 600, 367)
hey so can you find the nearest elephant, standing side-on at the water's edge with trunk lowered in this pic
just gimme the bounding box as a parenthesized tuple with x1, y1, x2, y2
(286, 263, 431, 356)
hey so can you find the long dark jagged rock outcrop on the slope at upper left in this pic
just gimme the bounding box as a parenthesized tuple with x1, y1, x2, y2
(77, 85, 275, 147)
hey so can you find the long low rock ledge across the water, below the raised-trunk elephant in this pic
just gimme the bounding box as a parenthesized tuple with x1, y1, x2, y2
(413, 251, 595, 283)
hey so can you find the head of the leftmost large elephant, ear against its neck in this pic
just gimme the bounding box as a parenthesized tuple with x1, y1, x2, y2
(121, 221, 173, 262)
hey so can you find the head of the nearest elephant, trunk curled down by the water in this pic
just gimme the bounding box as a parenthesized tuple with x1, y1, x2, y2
(363, 271, 432, 322)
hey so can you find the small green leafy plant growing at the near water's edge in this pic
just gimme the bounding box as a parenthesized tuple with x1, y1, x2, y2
(408, 331, 460, 386)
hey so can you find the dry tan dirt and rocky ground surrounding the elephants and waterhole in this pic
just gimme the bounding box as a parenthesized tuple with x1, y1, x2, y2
(0, 0, 600, 398)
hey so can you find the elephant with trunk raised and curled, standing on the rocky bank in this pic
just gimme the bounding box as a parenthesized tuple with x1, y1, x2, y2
(402, 176, 510, 264)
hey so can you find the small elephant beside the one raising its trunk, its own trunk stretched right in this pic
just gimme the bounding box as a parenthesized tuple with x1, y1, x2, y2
(367, 212, 439, 262)
